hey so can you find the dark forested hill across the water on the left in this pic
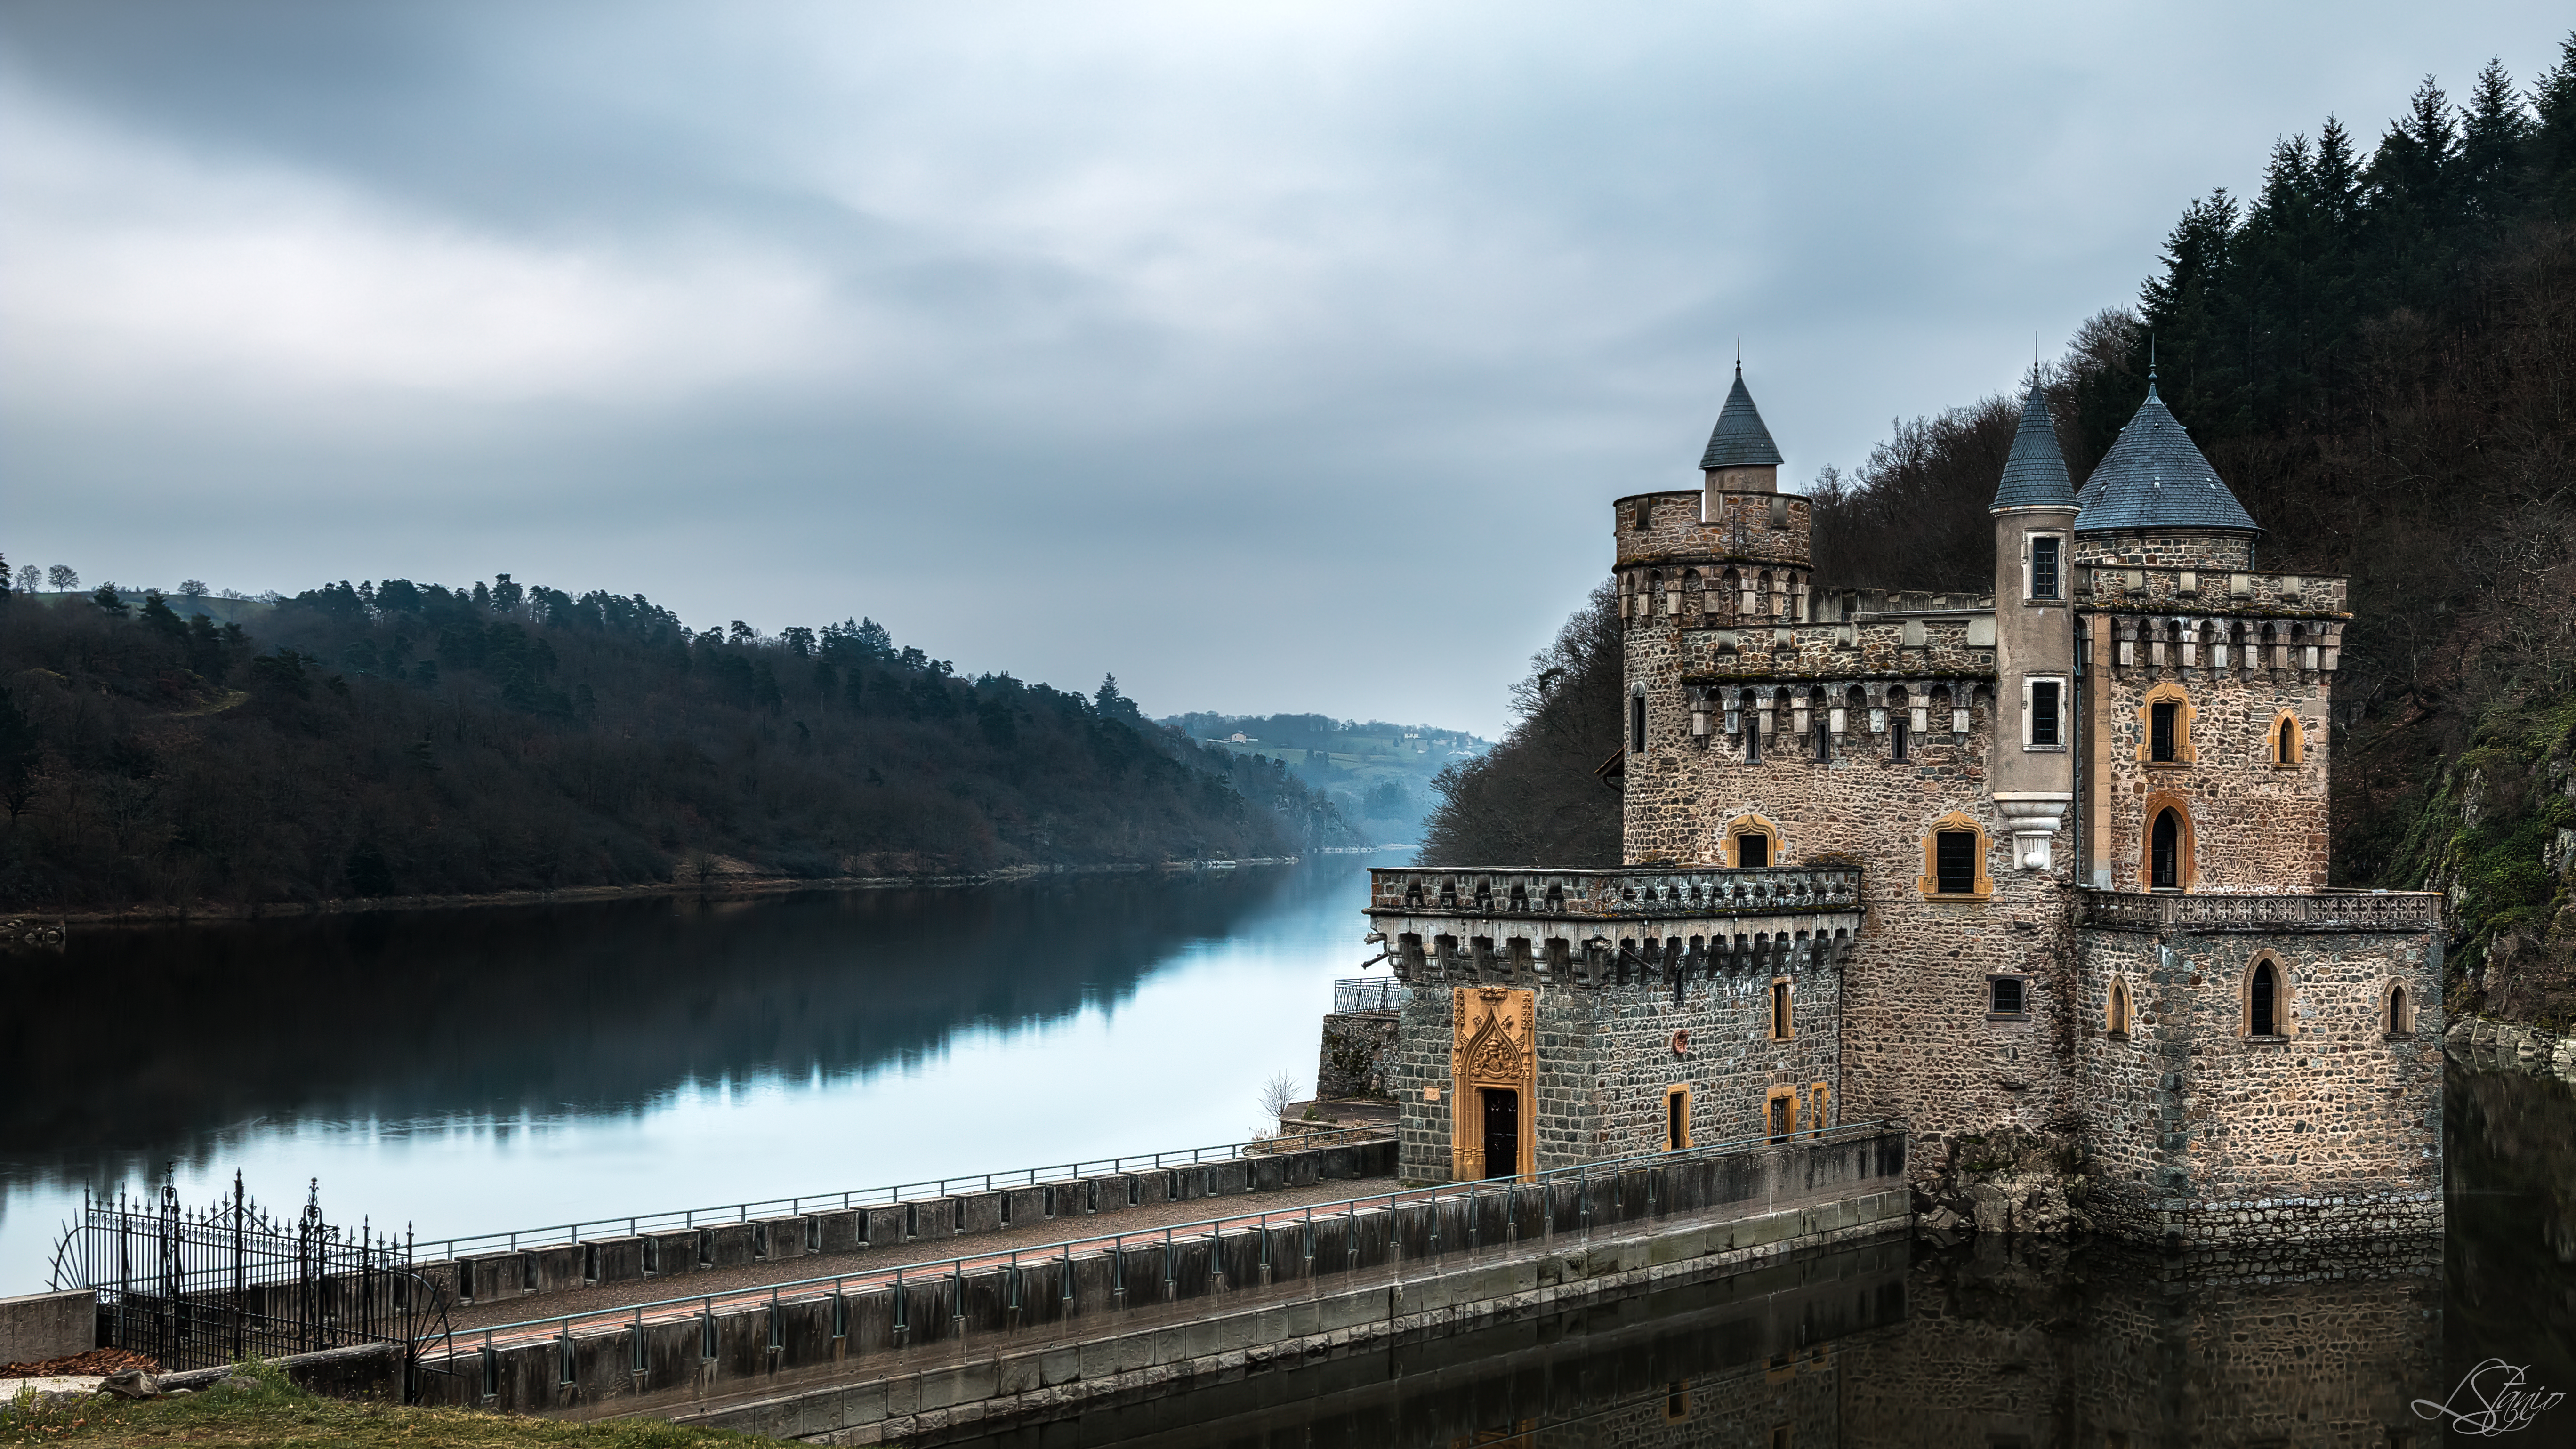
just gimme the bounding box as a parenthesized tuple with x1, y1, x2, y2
(0, 575, 1358, 910)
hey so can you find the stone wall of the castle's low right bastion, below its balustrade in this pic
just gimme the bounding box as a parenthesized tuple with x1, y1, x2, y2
(2076, 931, 2442, 1243)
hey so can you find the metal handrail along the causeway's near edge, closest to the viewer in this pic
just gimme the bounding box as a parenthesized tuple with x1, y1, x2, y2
(433, 1116, 1904, 1351)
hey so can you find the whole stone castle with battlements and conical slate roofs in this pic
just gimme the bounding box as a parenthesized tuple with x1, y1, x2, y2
(1368, 369, 2442, 1243)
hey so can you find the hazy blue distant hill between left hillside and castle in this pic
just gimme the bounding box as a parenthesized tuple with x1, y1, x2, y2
(1162, 714, 1494, 845)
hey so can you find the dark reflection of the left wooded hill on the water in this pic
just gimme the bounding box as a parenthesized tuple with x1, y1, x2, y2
(0, 866, 1342, 1170)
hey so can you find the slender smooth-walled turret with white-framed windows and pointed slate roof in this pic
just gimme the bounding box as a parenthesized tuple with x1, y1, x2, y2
(1988, 379, 2079, 871)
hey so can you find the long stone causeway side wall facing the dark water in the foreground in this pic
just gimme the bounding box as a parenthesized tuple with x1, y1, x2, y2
(420, 1132, 1911, 1441)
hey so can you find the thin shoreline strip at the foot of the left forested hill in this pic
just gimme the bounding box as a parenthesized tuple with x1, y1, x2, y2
(5, 856, 1301, 928)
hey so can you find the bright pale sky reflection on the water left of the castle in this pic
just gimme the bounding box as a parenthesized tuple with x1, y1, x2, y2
(0, 856, 1386, 1292)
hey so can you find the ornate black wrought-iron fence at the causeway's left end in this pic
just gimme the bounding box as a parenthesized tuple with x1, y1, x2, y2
(54, 1173, 448, 1385)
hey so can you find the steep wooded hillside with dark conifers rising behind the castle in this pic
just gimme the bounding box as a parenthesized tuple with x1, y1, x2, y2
(1432, 36, 2576, 1026)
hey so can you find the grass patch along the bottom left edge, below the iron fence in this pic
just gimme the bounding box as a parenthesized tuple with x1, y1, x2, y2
(0, 1364, 783, 1449)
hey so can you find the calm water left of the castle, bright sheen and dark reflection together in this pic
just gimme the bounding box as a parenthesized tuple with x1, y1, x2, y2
(0, 856, 1401, 1279)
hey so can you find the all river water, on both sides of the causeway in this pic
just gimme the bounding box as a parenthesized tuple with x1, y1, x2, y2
(0, 856, 2576, 1449)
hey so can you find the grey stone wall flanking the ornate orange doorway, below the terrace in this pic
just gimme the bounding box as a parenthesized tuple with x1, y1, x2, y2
(1393, 962, 1847, 1181)
